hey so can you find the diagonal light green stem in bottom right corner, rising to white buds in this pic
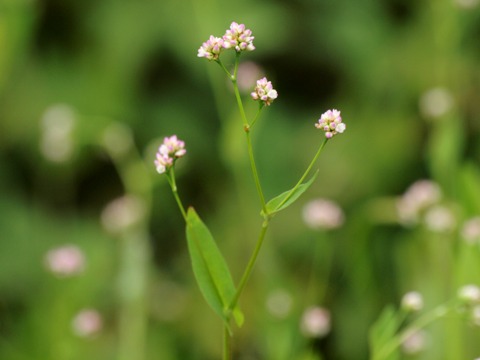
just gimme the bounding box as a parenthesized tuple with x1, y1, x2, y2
(373, 300, 458, 360)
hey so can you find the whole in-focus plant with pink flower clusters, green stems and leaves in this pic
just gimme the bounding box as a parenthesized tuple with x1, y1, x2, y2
(155, 22, 346, 359)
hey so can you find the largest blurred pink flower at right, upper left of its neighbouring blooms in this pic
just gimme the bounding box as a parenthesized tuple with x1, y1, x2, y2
(397, 180, 442, 225)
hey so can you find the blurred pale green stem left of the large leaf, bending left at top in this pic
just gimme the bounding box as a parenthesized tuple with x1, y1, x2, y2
(104, 125, 152, 360)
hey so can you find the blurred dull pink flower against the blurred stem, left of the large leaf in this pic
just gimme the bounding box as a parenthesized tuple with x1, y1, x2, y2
(101, 195, 146, 234)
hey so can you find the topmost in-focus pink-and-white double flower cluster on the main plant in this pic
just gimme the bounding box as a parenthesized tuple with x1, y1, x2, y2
(197, 22, 255, 60)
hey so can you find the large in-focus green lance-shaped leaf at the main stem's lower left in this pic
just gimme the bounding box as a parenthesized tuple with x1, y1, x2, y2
(186, 208, 243, 326)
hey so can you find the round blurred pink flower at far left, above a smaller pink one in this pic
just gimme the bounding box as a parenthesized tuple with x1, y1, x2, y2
(45, 245, 85, 277)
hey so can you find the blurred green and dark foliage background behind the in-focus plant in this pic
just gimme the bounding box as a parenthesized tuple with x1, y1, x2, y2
(0, 0, 480, 360)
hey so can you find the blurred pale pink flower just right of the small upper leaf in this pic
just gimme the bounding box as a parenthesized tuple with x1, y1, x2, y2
(303, 199, 345, 230)
